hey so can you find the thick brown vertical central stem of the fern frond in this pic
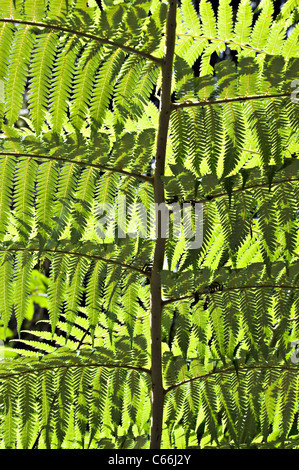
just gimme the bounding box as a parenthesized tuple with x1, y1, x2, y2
(150, 0, 177, 449)
